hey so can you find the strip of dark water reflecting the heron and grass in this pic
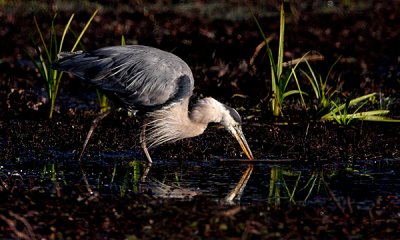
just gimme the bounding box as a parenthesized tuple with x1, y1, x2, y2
(0, 149, 400, 209)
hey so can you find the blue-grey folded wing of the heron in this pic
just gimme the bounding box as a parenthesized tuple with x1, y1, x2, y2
(54, 45, 194, 110)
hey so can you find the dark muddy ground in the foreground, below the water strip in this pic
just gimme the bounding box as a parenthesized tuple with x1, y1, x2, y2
(0, 189, 400, 239)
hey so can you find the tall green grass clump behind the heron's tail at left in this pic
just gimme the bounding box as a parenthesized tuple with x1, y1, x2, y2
(31, 10, 98, 119)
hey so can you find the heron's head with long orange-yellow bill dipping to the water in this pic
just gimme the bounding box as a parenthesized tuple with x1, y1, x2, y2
(220, 105, 254, 160)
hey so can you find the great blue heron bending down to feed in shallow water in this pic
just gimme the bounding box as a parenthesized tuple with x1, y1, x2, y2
(53, 45, 253, 163)
